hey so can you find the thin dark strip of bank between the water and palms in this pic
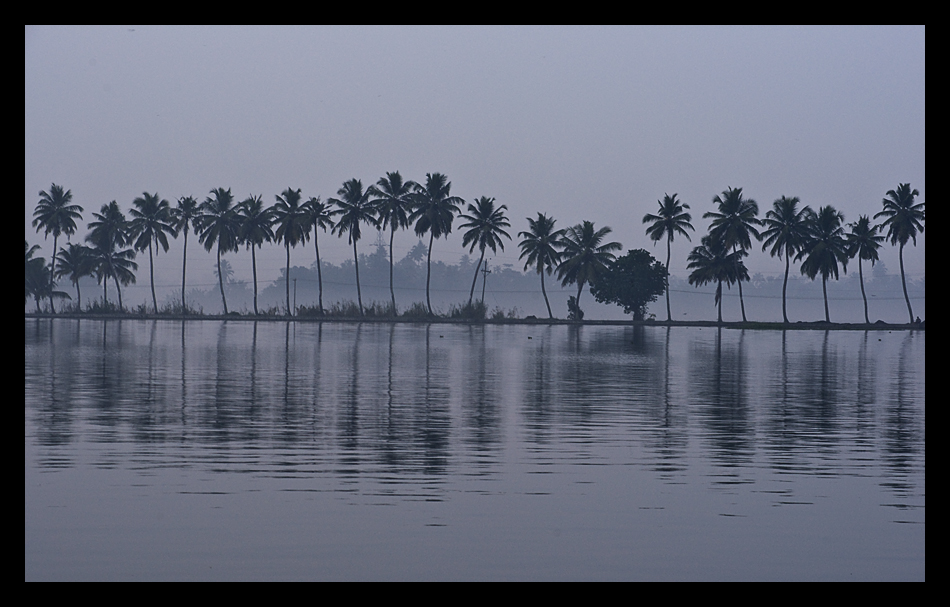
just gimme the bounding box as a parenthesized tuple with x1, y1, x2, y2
(25, 312, 925, 331)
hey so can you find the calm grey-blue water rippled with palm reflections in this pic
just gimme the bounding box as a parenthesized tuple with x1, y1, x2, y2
(25, 319, 926, 580)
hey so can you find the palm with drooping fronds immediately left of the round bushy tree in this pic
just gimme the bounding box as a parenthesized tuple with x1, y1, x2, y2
(557, 221, 623, 316)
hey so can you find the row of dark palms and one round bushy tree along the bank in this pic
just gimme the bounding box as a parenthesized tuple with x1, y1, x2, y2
(25, 176, 924, 323)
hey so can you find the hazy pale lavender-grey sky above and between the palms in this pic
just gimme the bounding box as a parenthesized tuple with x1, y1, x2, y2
(25, 25, 926, 288)
